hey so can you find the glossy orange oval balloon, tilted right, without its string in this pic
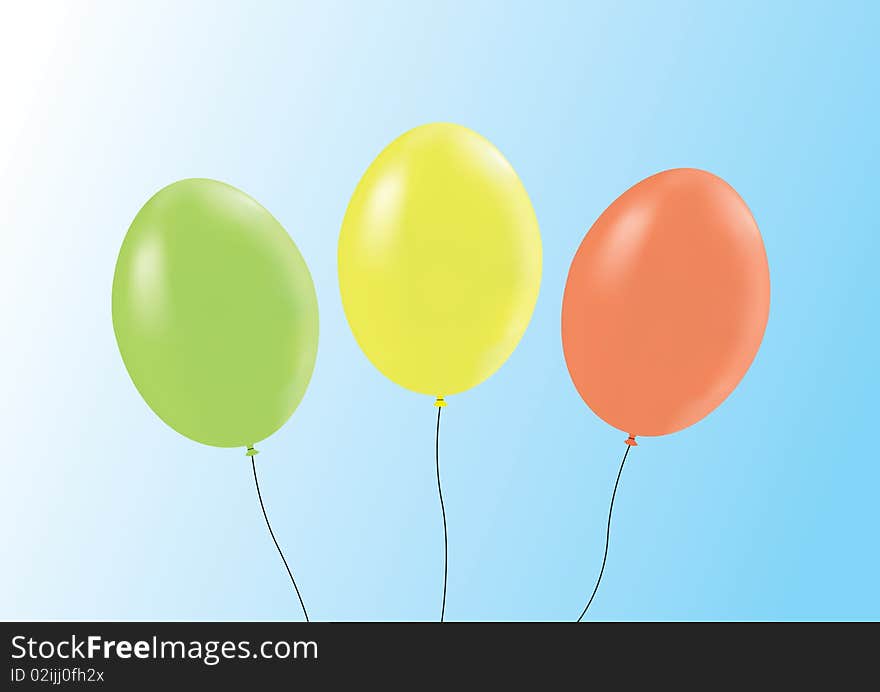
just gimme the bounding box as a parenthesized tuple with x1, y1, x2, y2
(562, 168, 770, 444)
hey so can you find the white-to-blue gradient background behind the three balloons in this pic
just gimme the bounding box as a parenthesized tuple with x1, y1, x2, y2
(0, 1, 880, 620)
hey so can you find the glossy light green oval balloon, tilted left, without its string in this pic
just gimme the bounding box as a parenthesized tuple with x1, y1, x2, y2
(113, 179, 318, 447)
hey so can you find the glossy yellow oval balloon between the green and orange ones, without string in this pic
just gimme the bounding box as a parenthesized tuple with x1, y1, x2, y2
(338, 123, 541, 396)
